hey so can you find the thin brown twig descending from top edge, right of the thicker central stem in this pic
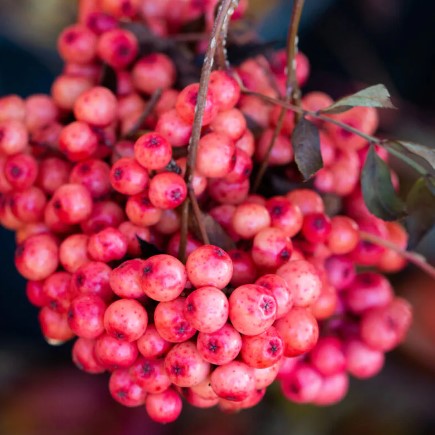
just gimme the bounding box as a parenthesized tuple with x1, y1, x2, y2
(252, 0, 305, 192)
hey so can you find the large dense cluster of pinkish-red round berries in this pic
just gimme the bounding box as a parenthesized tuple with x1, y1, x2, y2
(0, 0, 411, 422)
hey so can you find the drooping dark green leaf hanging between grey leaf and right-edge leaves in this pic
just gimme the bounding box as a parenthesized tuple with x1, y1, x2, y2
(361, 146, 406, 221)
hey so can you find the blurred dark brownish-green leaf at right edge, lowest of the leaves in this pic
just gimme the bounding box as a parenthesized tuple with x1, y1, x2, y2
(405, 177, 435, 245)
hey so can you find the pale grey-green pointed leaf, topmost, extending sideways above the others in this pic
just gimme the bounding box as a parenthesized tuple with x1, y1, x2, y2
(321, 85, 395, 114)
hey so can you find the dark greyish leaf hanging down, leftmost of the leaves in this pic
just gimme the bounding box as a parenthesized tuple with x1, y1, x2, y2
(292, 118, 323, 181)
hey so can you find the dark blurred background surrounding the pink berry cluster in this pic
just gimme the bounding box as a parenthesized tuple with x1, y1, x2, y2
(0, 0, 435, 435)
